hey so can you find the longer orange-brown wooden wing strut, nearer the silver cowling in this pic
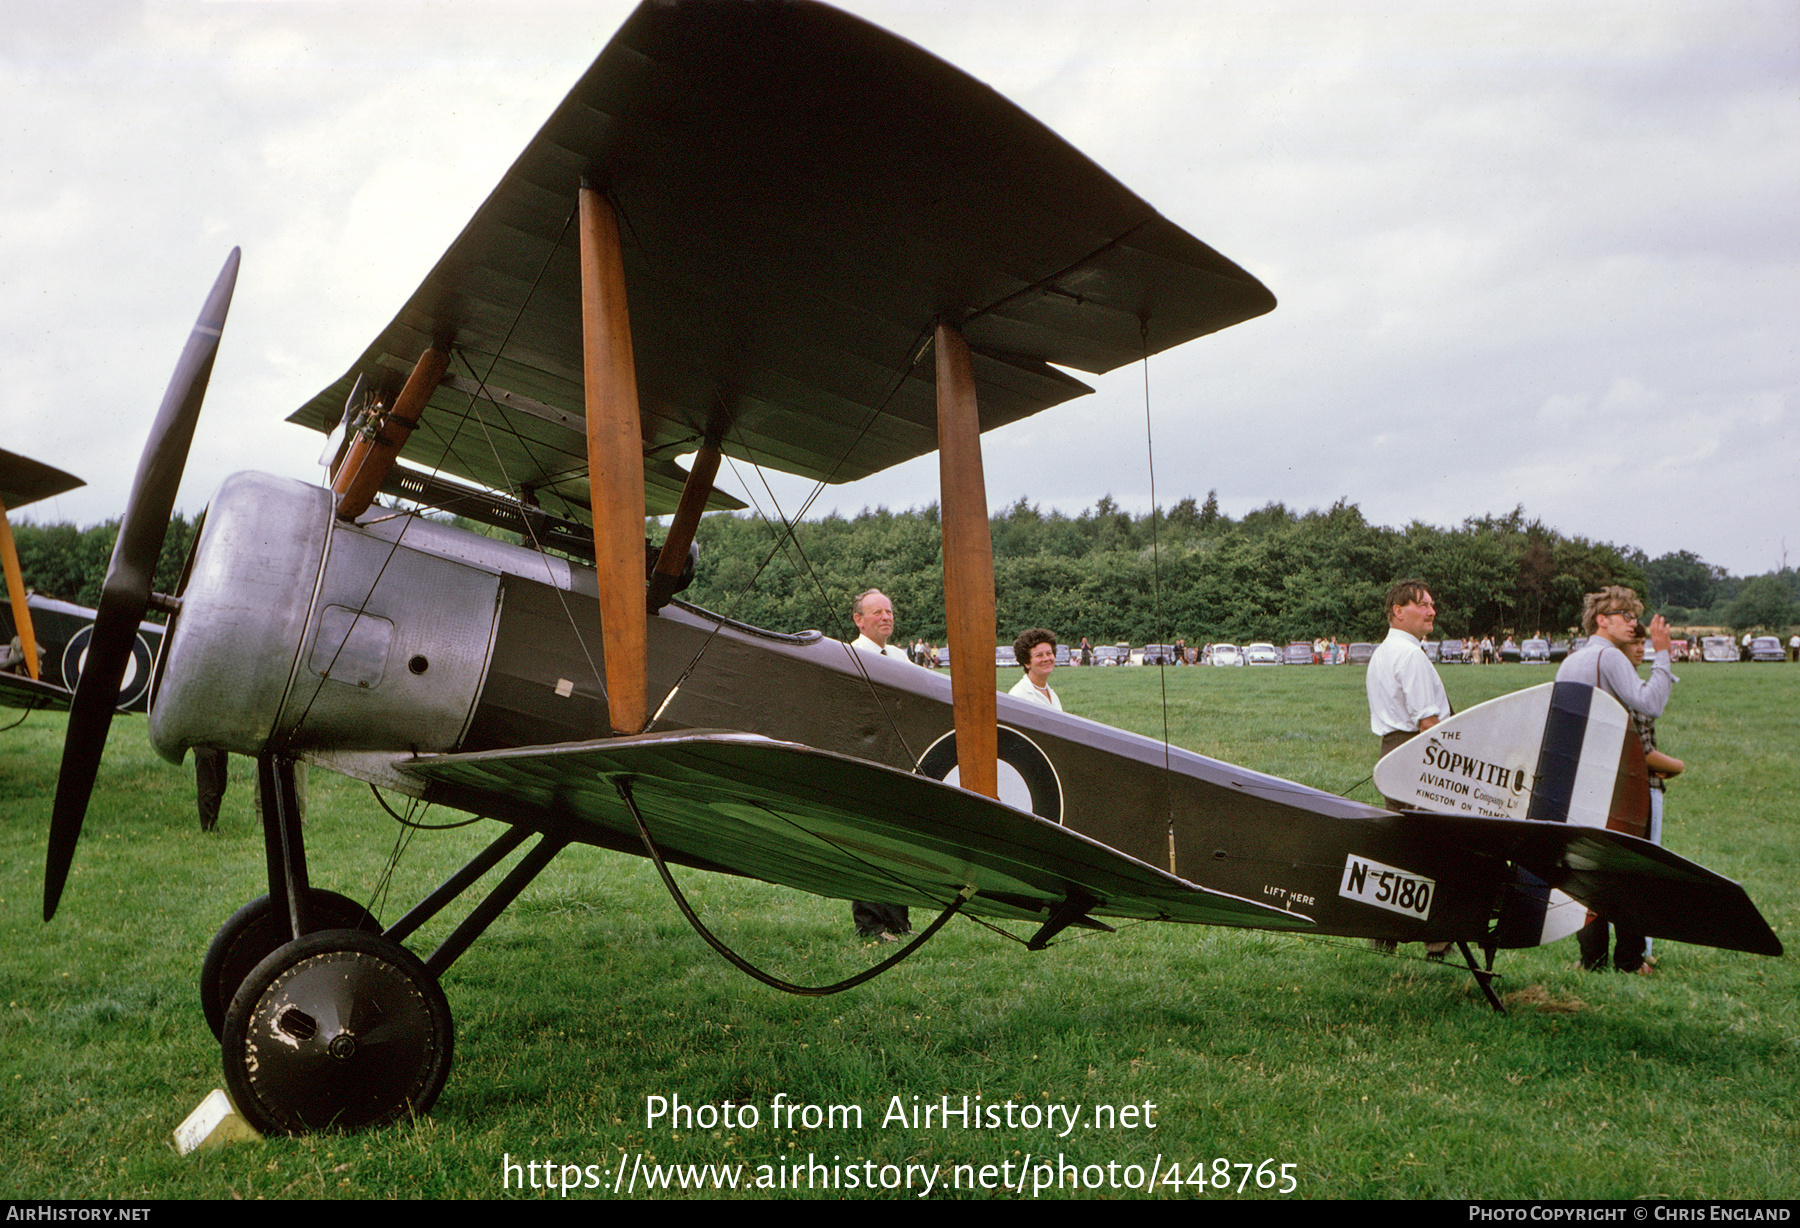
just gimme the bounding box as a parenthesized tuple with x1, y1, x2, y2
(578, 184, 650, 735)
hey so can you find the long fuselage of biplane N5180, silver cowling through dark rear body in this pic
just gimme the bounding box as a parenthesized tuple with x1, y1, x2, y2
(151, 474, 1508, 938)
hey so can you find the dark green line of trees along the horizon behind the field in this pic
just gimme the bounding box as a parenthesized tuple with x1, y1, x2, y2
(14, 493, 1800, 645)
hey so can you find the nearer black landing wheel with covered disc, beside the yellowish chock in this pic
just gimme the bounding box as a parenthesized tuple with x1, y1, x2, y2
(223, 929, 452, 1134)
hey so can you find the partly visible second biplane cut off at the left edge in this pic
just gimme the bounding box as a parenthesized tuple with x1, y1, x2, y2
(0, 448, 162, 711)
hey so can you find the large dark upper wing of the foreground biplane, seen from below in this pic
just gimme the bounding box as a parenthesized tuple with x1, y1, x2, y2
(292, 0, 1274, 517)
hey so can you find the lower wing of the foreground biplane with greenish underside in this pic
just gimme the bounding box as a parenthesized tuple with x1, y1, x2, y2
(400, 731, 1312, 929)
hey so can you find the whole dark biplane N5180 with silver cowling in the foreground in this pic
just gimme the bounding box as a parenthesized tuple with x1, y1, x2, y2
(45, 0, 1780, 1131)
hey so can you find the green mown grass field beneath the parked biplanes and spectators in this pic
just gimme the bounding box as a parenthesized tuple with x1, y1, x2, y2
(0, 664, 1800, 1197)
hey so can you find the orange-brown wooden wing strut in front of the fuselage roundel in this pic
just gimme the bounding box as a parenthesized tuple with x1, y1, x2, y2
(936, 324, 1001, 798)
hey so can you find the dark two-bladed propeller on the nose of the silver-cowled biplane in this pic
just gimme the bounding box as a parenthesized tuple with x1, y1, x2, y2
(43, 247, 239, 920)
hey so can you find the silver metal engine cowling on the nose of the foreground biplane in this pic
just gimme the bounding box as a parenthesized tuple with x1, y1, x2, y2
(151, 474, 513, 762)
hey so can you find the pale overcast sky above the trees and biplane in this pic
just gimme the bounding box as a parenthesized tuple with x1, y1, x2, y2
(0, 0, 1800, 574)
